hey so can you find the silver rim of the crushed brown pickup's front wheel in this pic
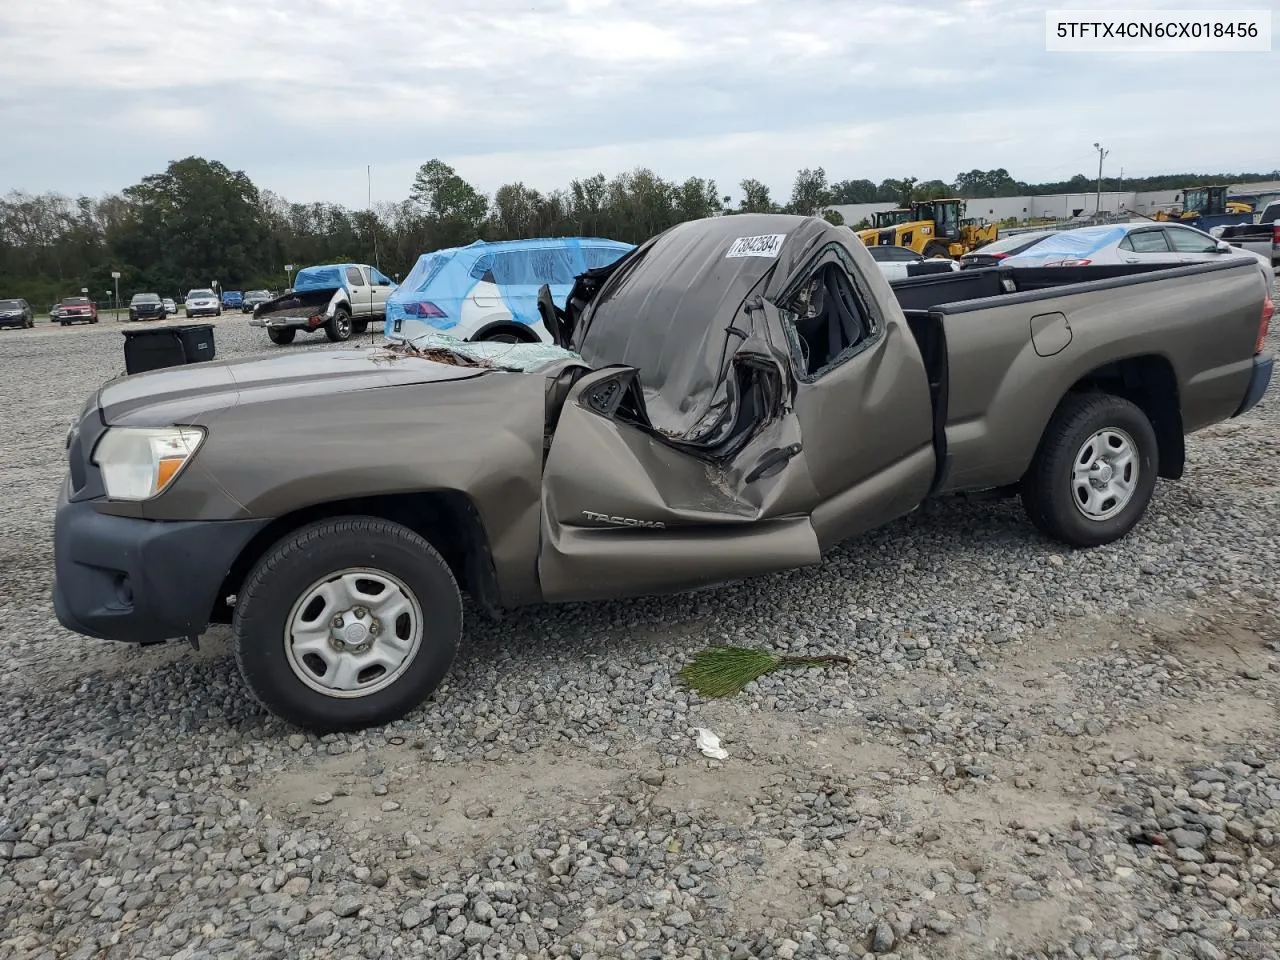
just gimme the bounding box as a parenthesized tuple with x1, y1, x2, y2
(284, 567, 422, 699)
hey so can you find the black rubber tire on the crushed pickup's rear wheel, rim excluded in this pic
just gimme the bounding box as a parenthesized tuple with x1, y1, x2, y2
(1021, 393, 1160, 547)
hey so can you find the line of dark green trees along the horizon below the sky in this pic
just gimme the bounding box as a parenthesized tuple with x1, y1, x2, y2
(0, 157, 1280, 308)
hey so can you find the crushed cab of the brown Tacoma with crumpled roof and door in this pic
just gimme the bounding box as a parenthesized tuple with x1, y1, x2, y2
(538, 216, 937, 600)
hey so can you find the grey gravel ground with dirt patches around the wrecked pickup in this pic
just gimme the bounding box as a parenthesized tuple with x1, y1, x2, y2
(0, 295, 1280, 960)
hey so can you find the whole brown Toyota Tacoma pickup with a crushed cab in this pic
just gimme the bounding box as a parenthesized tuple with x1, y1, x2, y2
(54, 215, 1272, 731)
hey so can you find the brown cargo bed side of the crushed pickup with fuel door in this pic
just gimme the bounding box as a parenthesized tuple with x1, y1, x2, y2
(900, 261, 1265, 493)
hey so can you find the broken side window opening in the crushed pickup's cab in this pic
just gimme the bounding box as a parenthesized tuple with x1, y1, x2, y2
(782, 262, 877, 379)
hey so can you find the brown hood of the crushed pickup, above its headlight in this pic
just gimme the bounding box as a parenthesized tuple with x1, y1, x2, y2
(97, 349, 493, 426)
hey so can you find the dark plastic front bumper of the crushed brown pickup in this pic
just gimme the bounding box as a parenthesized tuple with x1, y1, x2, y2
(54, 484, 269, 644)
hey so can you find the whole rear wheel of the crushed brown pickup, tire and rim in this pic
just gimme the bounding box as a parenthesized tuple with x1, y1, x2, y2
(1023, 393, 1160, 547)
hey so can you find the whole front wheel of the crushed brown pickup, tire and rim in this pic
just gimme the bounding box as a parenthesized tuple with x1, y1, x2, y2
(232, 517, 462, 732)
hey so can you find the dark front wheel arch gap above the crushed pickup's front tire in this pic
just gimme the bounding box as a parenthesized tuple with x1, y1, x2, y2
(210, 490, 500, 623)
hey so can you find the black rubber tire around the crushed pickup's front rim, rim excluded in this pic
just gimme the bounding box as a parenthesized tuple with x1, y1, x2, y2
(232, 516, 462, 733)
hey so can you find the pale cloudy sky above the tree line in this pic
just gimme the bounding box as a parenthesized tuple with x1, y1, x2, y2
(0, 0, 1280, 207)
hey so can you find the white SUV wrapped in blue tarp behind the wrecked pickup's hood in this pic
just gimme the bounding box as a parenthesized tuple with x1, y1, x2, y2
(385, 237, 635, 339)
